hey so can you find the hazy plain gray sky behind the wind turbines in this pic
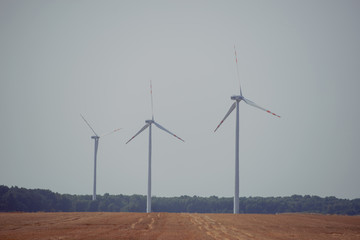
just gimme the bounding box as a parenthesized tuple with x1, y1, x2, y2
(0, 0, 360, 198)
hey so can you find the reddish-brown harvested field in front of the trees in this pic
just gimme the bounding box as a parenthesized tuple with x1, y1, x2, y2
(0, 213, 360, 240)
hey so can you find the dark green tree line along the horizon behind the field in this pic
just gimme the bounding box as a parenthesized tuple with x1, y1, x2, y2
(0, 185, 360, 215)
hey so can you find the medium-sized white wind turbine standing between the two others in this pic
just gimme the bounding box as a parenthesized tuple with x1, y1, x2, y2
(126, 81, 185, 213)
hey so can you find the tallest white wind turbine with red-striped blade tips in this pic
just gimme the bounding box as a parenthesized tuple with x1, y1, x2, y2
(214, 46, 280, 214)
